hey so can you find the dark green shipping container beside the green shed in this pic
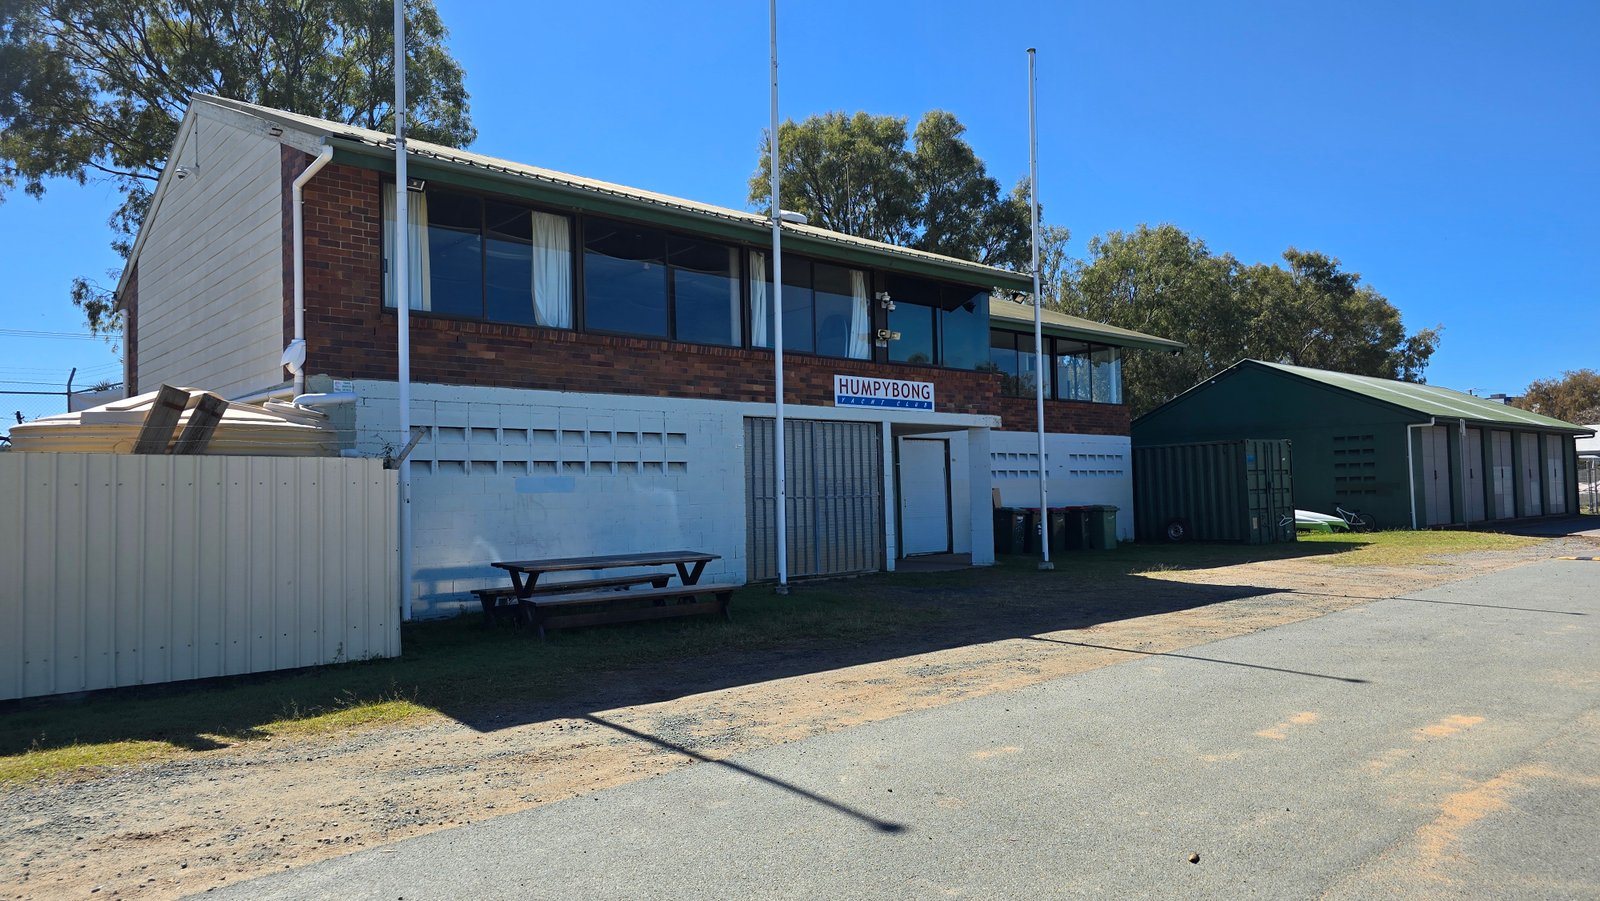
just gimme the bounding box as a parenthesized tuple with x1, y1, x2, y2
(1133, 438, 1294, 544)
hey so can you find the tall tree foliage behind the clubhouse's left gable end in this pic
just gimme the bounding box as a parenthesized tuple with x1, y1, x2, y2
(0, 0, 477, 331)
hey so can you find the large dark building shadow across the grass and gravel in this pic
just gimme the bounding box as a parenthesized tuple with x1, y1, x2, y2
(0, 541, 1354, 757)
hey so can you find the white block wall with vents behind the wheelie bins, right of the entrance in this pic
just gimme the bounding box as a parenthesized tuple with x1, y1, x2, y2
(989, 432, 1133, 541)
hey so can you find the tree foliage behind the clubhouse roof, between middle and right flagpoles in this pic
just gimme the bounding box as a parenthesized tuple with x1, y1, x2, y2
(750, 110, 1030, 269)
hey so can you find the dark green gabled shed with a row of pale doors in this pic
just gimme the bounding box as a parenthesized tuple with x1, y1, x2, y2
(1133, 360, 1594, 528)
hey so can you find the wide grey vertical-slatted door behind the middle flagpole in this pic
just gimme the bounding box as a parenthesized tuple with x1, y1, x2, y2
(744, 418, 883, 581)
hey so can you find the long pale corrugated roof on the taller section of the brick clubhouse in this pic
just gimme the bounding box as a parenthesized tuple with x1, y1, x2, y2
(194, 94, 1032, 290)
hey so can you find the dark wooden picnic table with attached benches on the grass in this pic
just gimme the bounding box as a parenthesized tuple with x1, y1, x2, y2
(486, 551, 739, 639)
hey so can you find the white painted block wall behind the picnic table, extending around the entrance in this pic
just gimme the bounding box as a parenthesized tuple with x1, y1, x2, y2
(354, 381, 995, 618)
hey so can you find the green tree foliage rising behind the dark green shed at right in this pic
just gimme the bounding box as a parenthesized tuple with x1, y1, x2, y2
(1059, 224, 1440, 414)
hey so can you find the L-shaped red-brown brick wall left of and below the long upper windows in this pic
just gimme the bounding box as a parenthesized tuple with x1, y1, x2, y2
(283, 157, 998, 424)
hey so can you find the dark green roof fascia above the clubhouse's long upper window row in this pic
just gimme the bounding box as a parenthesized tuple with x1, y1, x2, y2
(328, 138, 1034, 290)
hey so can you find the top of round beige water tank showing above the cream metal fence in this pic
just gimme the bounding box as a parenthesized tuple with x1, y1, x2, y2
(11, 386, 339, 456)
